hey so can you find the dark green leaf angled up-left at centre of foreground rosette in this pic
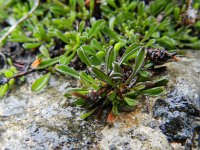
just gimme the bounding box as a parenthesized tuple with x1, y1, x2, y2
(91, 67, 113, 85)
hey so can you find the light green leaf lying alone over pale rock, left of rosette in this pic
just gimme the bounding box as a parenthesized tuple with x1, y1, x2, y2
(31, 73, 51, 92)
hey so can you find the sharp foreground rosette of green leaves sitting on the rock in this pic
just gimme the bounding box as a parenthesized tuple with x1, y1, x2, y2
(56, 45, 168, 122)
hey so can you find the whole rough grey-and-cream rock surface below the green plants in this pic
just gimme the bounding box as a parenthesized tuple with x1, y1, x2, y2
(0, 51, 200, 150)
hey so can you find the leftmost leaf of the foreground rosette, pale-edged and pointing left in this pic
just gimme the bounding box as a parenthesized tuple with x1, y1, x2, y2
(56, 65, 79, 78)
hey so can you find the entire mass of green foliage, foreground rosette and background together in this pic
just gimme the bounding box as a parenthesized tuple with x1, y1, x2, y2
(0, 0, 200, 119)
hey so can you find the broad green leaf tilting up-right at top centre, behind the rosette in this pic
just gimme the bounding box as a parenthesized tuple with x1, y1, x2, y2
(88, 19, 105, 39)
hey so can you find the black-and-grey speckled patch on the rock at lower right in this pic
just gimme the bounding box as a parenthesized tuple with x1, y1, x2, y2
(153, 94, 200, 146)
